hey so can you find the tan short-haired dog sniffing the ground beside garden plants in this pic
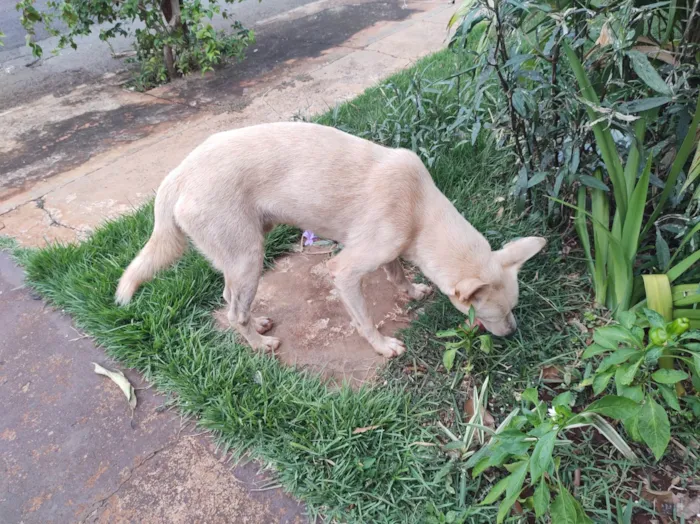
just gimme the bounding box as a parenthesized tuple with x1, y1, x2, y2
(116, 123, 546, 357)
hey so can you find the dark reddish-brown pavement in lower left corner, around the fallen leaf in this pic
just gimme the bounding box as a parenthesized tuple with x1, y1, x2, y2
(0, 253, 306, 524)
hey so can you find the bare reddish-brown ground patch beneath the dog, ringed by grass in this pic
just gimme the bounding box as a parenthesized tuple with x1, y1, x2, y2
(215, 247, 422, 388)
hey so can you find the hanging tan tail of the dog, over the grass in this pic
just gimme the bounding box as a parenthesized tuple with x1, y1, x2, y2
(115, 179, 187, 305)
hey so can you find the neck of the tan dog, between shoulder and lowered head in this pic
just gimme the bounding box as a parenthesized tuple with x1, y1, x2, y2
(408, 188, 492, 295)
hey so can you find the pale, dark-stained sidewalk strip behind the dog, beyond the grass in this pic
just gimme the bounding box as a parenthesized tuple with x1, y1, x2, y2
(0, 0, 455, 245)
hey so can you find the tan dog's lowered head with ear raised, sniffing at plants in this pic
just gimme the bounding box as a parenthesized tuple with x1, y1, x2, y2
(450, 237, 547, 336)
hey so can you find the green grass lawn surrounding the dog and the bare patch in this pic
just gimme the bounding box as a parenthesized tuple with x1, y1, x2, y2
(8, 46, 696, 523)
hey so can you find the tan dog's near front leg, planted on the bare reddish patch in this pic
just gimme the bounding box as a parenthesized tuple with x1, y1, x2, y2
(328, 252, 406, 358)
